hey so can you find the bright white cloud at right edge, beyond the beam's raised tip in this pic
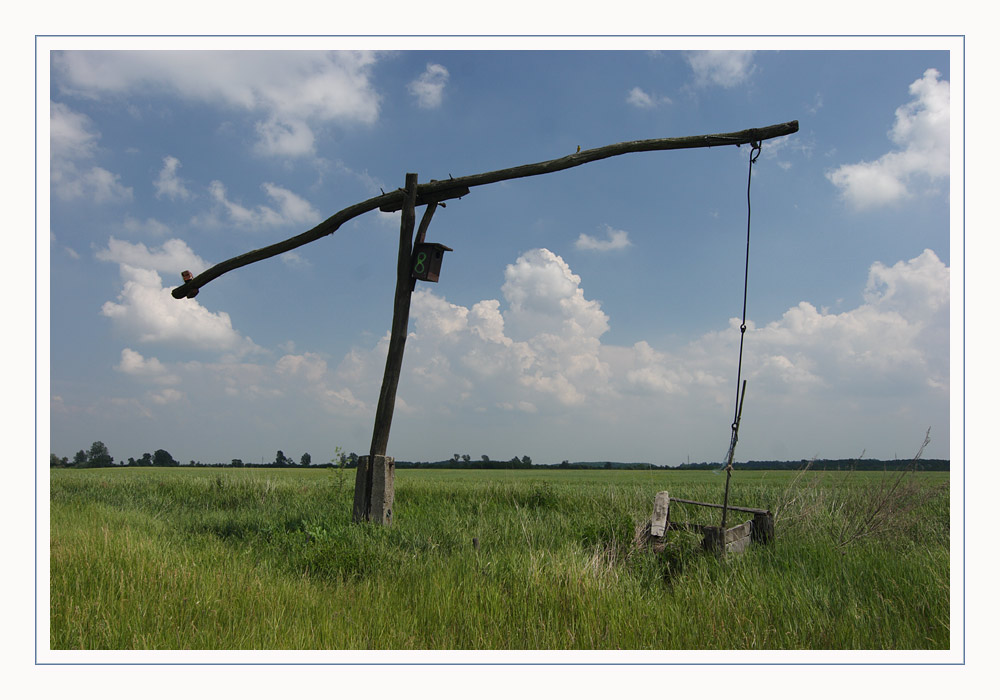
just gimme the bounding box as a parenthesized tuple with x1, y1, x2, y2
(827, 68, 951, 209)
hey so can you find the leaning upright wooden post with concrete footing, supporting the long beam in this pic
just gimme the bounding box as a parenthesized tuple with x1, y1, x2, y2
(353, 173, 417, 524)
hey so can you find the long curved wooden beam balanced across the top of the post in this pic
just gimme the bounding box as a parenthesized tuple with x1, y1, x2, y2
(171, 121, 799, 299)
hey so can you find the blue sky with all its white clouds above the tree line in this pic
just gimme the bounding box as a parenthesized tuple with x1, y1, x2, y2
(45, 40, 961, 464)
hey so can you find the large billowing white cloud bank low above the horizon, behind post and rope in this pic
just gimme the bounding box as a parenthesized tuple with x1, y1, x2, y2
(310, 249, 949, 458)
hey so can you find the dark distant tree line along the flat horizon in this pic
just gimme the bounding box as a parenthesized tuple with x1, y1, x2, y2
(50, 440, 951, 472)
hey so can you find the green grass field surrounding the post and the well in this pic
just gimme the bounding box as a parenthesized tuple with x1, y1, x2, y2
(50, 468, 949, 649)
